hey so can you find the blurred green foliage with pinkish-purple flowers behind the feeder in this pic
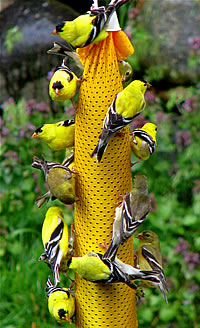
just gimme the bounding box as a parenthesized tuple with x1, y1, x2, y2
(0, 1, 200, 328)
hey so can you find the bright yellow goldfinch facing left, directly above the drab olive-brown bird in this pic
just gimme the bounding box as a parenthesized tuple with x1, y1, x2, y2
(32, 120, 75, 150)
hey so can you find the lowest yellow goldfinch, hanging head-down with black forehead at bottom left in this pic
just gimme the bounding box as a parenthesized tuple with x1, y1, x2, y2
(46, 277, 75, 323)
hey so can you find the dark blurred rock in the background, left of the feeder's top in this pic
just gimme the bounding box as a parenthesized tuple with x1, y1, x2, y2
(0, 0, 78, 102)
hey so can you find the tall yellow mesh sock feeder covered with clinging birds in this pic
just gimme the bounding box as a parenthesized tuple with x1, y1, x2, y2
(75, 31, 137, 328)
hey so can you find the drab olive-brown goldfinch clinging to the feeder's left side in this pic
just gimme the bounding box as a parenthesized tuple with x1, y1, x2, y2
(32, 156, 75, 207)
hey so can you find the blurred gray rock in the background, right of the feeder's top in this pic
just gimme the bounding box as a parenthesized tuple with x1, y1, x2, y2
(133, 0, 200, 84)
